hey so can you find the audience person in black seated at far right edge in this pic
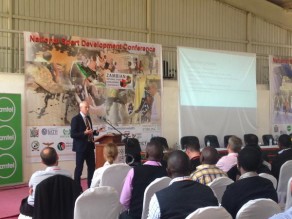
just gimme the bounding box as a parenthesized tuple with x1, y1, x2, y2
(272, 134, 292, 179)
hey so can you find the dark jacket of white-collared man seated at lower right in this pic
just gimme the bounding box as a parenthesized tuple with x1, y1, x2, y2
(221, 176, 278, 218)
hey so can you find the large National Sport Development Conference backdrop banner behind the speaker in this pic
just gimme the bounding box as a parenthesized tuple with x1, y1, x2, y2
(24, 32, 162, 161)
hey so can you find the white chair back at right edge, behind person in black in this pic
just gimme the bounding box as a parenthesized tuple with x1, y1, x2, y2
(277, 160, 292, 205)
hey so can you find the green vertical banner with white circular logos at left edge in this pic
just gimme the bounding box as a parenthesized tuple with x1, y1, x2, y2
(0, 93, 22, 186)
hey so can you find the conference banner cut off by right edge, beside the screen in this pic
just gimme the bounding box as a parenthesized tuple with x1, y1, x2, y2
(269, 56, 292, 140)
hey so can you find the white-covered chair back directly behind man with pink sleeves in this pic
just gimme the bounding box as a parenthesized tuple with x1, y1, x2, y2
(141, 176, 171, 219)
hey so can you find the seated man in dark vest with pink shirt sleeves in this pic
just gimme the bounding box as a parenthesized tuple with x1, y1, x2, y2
(120, 141, 167, 219)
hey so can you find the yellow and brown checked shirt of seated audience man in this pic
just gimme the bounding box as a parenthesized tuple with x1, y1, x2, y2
(191, 164, 227, 185)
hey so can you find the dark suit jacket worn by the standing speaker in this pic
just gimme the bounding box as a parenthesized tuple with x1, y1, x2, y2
(71, 113, 98, 152)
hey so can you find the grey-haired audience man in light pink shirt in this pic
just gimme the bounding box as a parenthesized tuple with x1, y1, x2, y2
(216, 136, 242, 172)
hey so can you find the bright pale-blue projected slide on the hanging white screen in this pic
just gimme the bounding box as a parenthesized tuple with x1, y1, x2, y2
(179, 48, 256, 107)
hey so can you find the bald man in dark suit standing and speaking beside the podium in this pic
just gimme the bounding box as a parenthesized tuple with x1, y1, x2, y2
(71, 101, 99, 188)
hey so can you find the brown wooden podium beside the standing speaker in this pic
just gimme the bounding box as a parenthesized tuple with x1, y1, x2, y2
(94, 134, 124, 168)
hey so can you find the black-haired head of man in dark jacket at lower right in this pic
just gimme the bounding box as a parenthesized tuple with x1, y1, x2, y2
(237, 147, 262, 174)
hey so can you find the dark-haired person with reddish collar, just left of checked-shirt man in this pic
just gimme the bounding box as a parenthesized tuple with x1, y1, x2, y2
(184, 141, 201, 173)
